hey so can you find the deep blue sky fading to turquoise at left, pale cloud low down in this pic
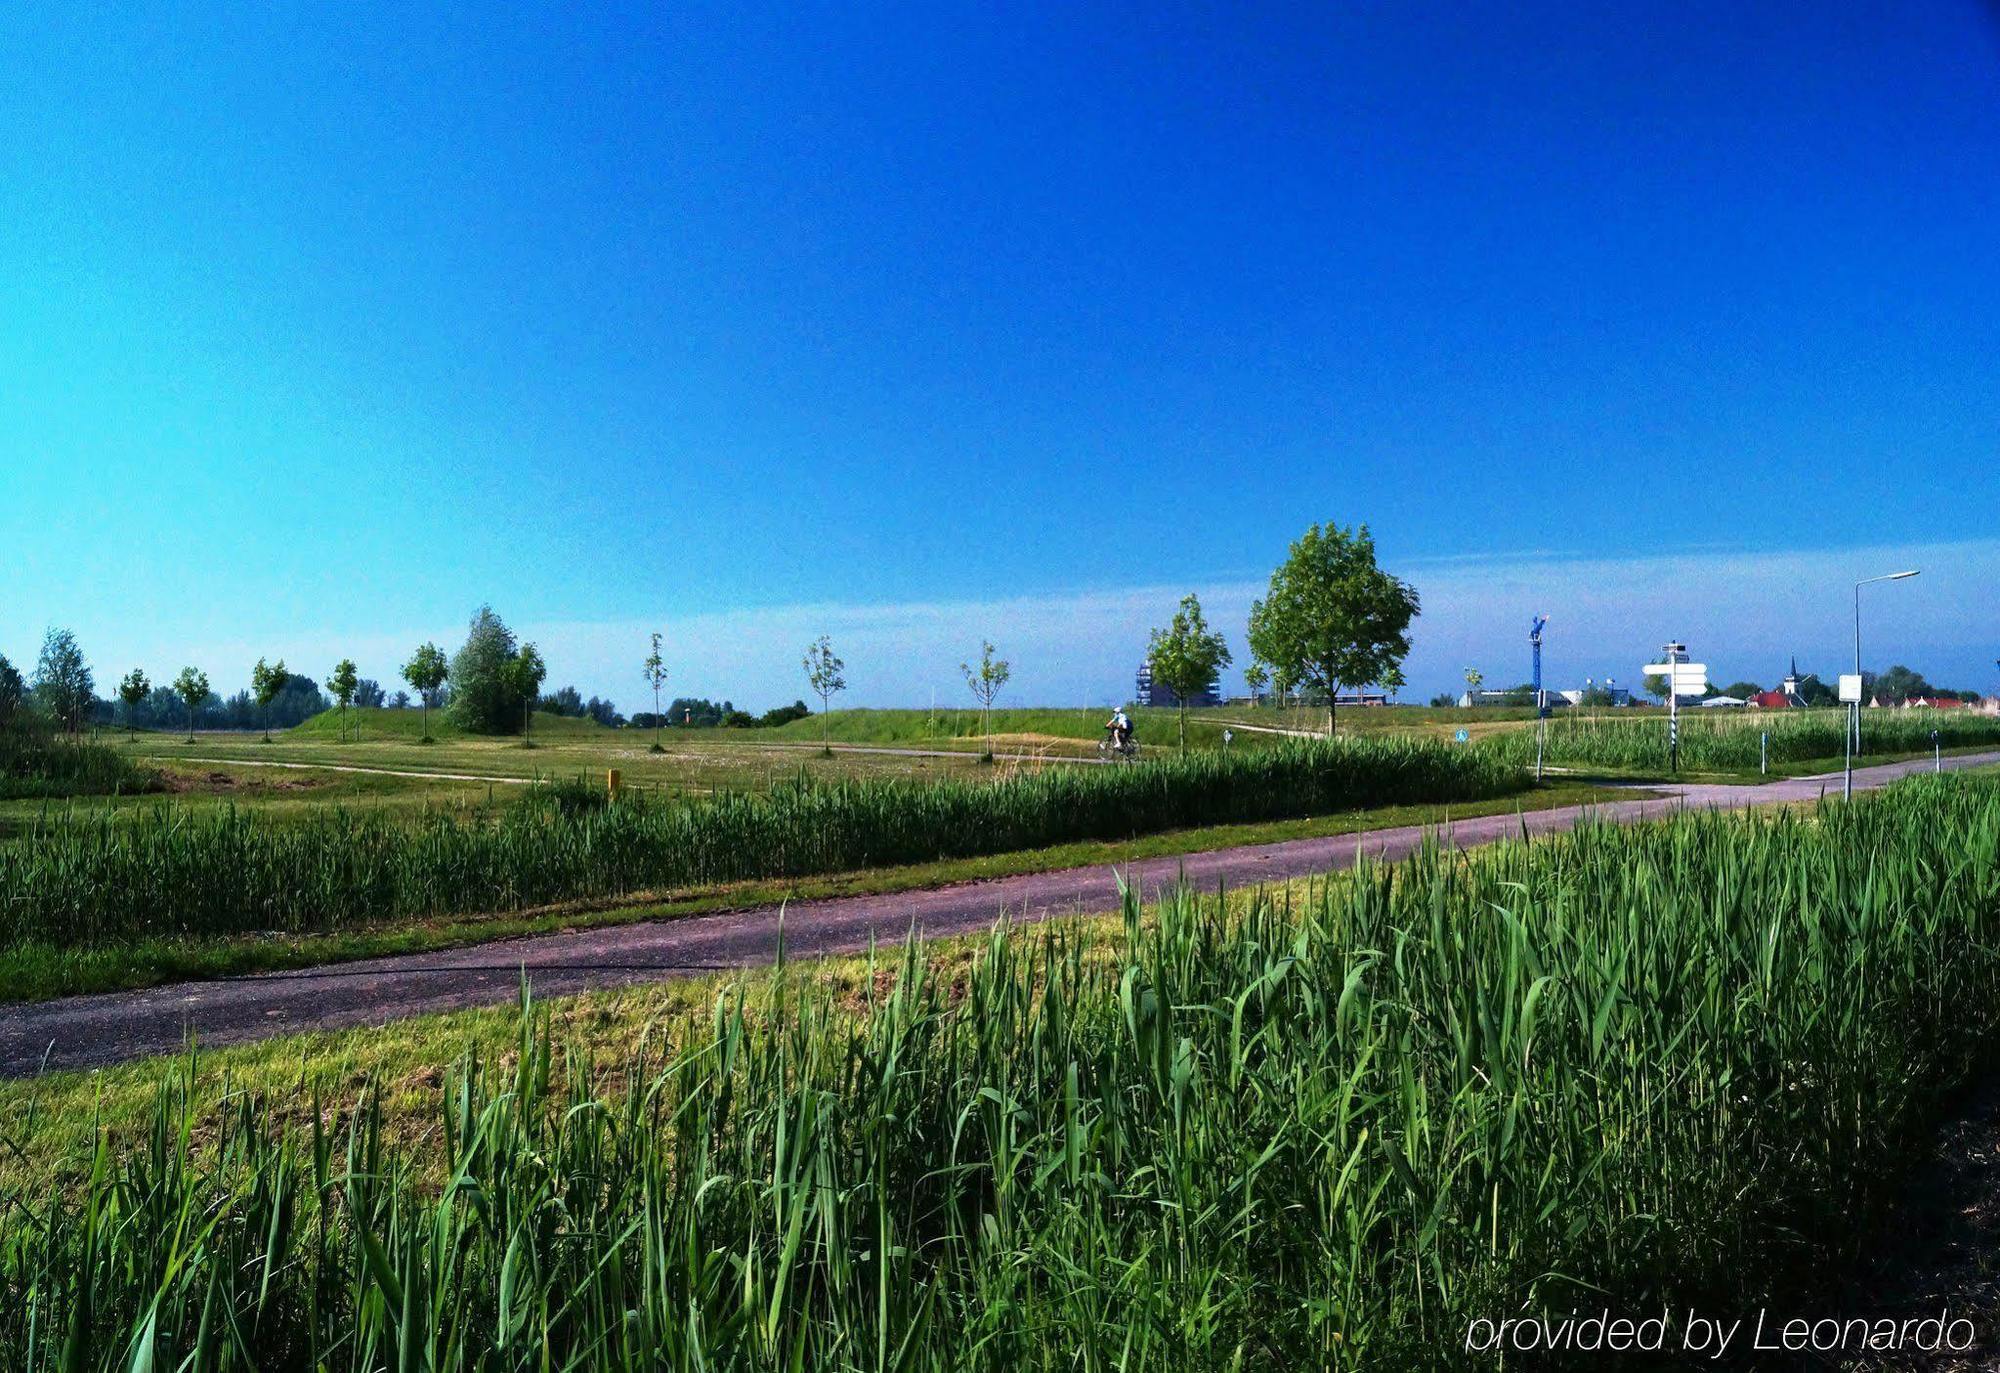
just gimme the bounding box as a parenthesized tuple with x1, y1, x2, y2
(0, 0, 2000, 707)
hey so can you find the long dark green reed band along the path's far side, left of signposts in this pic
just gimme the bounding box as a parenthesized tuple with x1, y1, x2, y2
(0, 741, 1526, 947)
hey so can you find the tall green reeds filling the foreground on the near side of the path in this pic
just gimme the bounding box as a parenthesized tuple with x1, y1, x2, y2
(0, 779, 2000, 1371)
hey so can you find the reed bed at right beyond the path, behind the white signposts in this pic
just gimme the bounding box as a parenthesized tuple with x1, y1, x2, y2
(1478, 709, 2000, 773)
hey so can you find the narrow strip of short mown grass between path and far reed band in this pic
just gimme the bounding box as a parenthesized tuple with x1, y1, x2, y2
(0, 783, 1616, 1001)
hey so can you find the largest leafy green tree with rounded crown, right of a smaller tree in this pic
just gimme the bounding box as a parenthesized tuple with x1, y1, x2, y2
(1250, 524, 1418, 737)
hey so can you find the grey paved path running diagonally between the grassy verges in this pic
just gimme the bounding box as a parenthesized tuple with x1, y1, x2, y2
(0, 753, 2000, 1077)
